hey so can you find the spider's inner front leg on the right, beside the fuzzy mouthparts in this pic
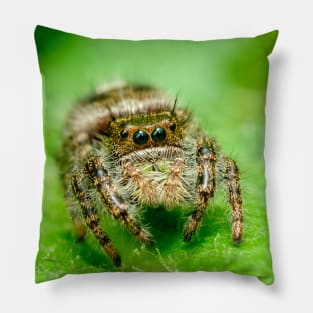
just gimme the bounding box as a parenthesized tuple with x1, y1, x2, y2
(184, 139, 216, 241)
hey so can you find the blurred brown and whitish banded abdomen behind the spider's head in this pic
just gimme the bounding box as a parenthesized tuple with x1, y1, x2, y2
(66, 86, 172, 139)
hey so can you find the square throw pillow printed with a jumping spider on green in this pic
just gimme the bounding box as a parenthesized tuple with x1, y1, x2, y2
(35, 26, 278, 285)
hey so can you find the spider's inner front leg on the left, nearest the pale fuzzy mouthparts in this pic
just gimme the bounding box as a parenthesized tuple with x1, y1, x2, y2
(85, 157, 154, 246)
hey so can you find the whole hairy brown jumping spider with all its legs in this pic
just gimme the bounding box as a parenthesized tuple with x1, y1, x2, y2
(60, 86, 243, 266)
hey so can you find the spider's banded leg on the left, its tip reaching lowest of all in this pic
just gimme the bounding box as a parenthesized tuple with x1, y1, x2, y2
(71, 174, 121, 266)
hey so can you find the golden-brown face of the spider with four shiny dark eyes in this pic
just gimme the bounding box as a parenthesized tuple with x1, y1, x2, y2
(110, 111, 183, 156)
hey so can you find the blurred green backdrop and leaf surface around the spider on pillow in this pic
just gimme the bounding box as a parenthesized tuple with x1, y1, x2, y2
(35, 26, 278, 284)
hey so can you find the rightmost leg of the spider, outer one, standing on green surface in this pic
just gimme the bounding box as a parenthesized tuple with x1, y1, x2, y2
(223, 158, 243, 244)
